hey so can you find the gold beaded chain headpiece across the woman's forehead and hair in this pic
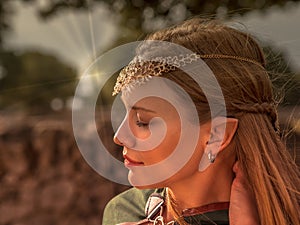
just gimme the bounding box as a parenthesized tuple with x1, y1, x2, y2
(112, 53, 263, 96)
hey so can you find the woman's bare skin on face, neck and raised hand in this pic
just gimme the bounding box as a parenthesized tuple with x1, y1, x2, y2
(114, 79, 257, 225)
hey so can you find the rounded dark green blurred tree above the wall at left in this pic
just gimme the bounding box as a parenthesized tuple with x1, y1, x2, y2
(0, 52, 77, 113)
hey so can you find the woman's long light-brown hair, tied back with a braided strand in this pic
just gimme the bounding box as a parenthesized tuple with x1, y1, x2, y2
(140, 18, 300, 225)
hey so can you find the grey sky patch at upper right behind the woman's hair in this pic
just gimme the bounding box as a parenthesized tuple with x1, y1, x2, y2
(236, 3, 300, 72)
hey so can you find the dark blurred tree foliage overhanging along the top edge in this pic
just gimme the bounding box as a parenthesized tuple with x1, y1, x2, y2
(0, 0, 300, 48)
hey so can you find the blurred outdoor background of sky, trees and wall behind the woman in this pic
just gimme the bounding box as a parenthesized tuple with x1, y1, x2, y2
(0, 0, 300, 225)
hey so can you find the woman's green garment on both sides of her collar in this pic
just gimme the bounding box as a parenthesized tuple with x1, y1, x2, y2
(102, 188, 229, 225)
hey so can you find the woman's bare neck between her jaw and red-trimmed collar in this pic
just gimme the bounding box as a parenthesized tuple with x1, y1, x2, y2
(167, 164, 233, 212)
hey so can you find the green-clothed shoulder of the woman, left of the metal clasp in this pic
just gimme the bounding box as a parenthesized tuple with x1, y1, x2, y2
(102, 188, 161, 225)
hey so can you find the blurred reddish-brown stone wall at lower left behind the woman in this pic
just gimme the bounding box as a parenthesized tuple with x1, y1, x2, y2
(0, 115, 128, 225)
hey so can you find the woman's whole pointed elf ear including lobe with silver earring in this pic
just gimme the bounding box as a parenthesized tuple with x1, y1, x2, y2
(199, 117, 238, 171)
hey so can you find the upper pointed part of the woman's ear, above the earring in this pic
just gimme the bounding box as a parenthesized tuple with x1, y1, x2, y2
(207, 117, 238, 155)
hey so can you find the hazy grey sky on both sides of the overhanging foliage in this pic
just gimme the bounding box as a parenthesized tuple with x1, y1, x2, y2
(5, 0, 300, 71)
